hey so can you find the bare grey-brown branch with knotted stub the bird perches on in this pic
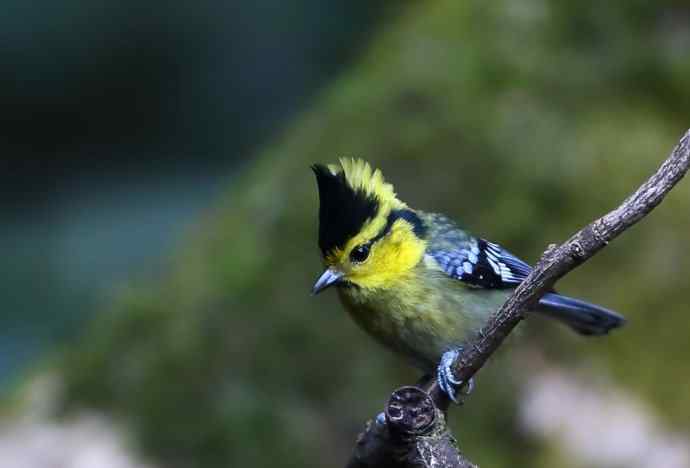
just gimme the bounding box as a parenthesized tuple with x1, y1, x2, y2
(348, 130, 690, 468)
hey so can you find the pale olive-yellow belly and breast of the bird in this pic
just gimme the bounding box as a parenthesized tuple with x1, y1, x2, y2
(339, 276, 510, 372)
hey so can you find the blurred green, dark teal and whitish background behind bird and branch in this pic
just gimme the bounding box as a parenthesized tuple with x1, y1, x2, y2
(0, 0, 690, 468)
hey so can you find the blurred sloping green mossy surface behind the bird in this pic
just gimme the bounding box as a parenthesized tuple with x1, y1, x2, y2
(57, 0, 690, 468)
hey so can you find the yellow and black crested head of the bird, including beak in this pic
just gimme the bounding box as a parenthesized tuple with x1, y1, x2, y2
(312, 159, 426, 294)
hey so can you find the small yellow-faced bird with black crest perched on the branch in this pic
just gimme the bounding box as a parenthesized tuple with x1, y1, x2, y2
(312, 158, 625, 403)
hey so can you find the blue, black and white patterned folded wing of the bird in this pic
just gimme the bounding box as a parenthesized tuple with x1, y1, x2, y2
(428, 237, 532, 289)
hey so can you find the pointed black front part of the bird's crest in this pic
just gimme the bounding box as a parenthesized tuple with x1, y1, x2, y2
(311, 164, 379, 256)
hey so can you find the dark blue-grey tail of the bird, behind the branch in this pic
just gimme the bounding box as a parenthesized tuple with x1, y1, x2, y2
(536, 293, 625, 335)
